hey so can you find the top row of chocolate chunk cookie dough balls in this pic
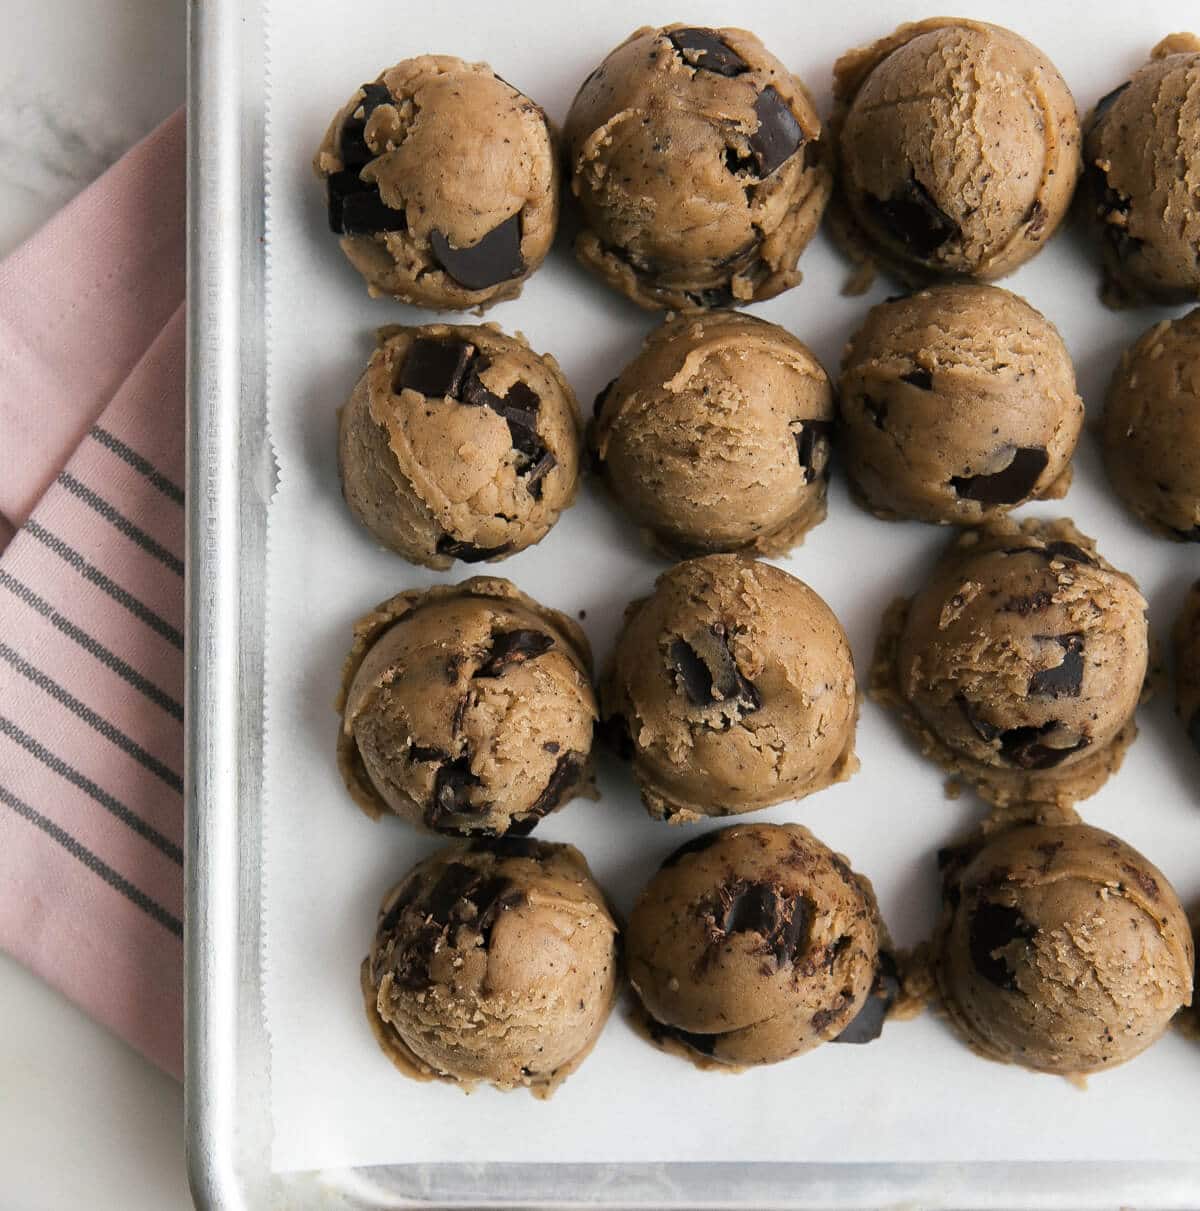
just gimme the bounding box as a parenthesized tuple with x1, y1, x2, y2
(315, 17, 1200, 311)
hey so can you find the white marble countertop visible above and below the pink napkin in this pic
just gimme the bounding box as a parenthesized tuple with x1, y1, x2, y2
(0, 0, 191, 1211)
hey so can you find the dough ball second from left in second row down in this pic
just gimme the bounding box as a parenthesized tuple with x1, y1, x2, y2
(591, 311, 833, 556)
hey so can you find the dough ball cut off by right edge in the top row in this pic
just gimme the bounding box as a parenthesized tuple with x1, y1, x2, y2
(1080, 34, 1200, 306)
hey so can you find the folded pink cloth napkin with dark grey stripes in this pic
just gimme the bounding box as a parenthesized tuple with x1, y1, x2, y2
(0, 111, 185, 1074)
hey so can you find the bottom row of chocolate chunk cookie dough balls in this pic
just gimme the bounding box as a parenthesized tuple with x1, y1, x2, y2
(361, 822, 1195, 1097)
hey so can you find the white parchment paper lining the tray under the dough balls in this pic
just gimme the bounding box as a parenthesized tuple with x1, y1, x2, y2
(263, 0, 1200, 1170)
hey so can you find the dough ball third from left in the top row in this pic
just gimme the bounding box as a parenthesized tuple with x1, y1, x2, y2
(833, 17, 1080, 281)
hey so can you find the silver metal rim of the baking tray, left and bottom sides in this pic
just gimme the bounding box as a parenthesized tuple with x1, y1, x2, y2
(185, 0, 1200, 1211)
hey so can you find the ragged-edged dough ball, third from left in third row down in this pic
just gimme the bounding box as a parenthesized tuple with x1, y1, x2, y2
(872, 522, 1149, 807)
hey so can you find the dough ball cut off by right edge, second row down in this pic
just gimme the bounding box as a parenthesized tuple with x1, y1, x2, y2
(1103, 310, 1200, 543)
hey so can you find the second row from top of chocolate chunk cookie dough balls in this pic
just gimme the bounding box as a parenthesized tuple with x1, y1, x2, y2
(339, 300, 1200, 568)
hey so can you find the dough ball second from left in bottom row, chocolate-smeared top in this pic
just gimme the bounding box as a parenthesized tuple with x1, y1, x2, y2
(625, 825, 898, 1068)
